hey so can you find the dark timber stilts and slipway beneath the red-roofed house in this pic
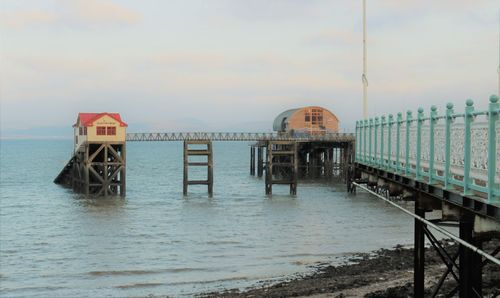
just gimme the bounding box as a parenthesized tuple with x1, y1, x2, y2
(54, 142, 126, 196)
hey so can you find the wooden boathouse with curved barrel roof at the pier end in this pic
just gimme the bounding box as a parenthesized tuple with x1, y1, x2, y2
(273, 106, 340, 134)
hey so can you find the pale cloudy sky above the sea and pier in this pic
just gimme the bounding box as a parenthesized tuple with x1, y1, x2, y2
(0, 0, 500, 138)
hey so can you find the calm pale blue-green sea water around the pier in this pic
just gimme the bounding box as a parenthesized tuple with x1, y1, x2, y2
(0, 141, 413, 297)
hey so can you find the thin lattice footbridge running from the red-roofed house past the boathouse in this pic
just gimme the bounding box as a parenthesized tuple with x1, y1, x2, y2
(127, 132, 354, 142)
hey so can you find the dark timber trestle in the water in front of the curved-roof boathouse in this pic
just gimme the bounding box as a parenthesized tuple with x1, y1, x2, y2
(266, 141, 298, 195)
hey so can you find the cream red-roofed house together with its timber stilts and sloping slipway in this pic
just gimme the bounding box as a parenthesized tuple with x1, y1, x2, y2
(54, 112, 127, 196)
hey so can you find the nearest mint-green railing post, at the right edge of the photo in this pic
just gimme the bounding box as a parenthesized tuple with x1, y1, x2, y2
(488, 95, 500, 203)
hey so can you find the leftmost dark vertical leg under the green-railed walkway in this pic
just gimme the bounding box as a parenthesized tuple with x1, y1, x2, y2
(413, 197, 425, 297)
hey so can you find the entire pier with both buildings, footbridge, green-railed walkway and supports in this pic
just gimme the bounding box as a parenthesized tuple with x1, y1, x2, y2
(54, 100, 500, 297)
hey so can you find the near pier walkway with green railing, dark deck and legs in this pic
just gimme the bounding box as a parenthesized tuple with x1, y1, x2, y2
(349, 96, 500, 298)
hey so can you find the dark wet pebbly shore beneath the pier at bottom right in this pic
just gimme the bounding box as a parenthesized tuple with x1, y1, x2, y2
(200, 240, 500, 298)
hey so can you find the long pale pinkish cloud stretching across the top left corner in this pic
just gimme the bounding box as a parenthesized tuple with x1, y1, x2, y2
(0, 0, 142, 29)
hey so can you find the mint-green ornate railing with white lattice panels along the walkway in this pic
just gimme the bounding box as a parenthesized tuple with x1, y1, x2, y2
(355, 95, 500, 204)
